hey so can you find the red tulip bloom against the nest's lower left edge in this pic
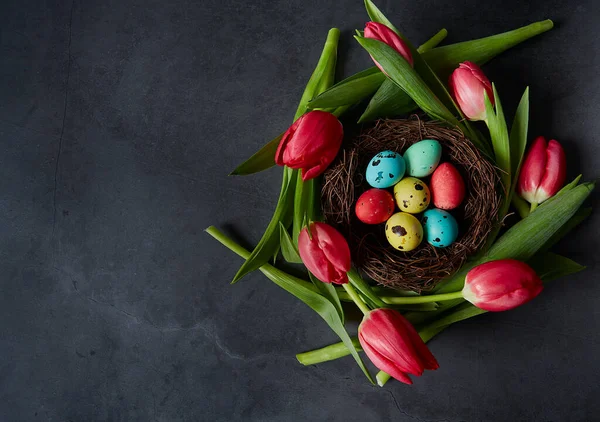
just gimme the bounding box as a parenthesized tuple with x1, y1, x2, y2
(298, 223, 351, 284)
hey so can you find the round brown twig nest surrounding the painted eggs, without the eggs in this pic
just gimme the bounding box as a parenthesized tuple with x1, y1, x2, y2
(321, 118, 500, 292)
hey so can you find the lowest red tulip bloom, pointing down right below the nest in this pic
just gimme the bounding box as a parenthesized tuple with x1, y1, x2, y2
(358, 309, 439, 384)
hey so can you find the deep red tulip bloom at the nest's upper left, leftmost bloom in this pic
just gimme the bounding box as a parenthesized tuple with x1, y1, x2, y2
(275, 110, 344, 180)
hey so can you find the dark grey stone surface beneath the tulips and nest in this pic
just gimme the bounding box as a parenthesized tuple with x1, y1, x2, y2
(0, 0, 600, 422)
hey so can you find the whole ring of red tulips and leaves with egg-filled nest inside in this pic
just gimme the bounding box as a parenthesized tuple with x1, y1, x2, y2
(206, 0, 595, 386)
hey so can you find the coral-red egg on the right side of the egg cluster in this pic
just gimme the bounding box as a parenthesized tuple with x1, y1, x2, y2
(429, 163, 465, 210)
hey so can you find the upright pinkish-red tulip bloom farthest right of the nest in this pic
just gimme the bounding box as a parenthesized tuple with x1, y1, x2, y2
(517, 136, 567, 204)
